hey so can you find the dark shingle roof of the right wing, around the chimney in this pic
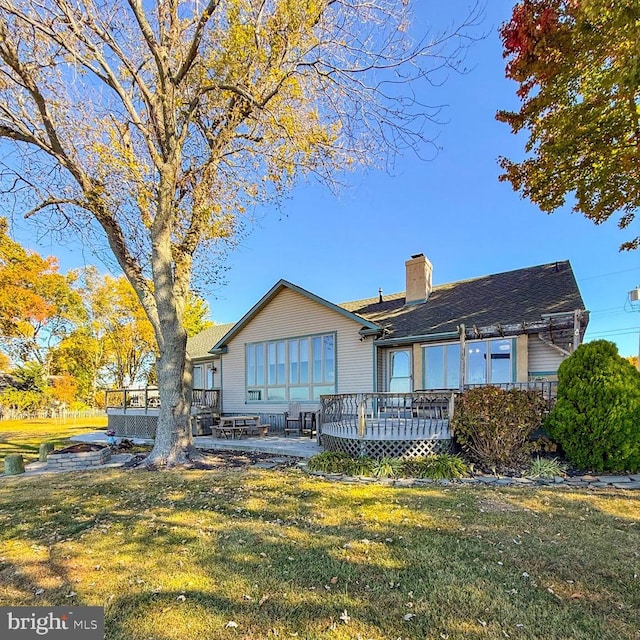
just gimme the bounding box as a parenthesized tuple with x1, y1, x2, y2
(339, 261, 585, 339)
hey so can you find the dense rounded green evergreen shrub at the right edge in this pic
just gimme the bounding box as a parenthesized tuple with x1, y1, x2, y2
(546, 340, 640, 471)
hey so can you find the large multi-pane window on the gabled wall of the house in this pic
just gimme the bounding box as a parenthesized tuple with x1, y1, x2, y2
(245, 334, 336, 402)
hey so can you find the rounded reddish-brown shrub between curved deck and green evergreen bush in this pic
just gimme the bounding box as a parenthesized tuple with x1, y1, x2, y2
(451, 386, 546, 468)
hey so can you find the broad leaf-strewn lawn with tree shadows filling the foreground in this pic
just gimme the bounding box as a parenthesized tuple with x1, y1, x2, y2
(0, 469, 640, 640)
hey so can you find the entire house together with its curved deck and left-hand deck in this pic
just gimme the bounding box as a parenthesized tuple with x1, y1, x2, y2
(106, 254, 589, 450)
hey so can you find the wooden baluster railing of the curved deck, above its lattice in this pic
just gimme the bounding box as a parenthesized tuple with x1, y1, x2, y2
(320, 391, 455, 440)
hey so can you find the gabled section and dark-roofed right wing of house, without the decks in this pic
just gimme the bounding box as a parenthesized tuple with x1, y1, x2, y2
(198, 254, 589, 422)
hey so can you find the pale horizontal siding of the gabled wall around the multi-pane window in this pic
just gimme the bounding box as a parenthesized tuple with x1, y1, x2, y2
(222, 288, 373, 413)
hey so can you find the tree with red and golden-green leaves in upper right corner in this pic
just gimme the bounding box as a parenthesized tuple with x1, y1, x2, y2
(497, 0, 640, 250)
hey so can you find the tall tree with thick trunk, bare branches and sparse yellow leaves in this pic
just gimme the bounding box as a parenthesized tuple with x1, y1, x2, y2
(0, 0, 477, 466)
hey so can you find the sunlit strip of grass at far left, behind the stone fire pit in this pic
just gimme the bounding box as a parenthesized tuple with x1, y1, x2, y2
(0, 416, 107, 473)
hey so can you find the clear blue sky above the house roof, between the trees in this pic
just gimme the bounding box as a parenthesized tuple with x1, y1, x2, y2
(7, 0, 640, 355)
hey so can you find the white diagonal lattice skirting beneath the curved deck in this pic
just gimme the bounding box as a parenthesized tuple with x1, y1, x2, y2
(321, 434, 452, 459)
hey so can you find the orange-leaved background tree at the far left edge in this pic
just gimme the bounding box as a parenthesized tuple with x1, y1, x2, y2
(0, 218, 83, 365)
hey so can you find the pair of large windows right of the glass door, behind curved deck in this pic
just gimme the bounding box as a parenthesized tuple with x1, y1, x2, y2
(423, 338, 513, 389)
